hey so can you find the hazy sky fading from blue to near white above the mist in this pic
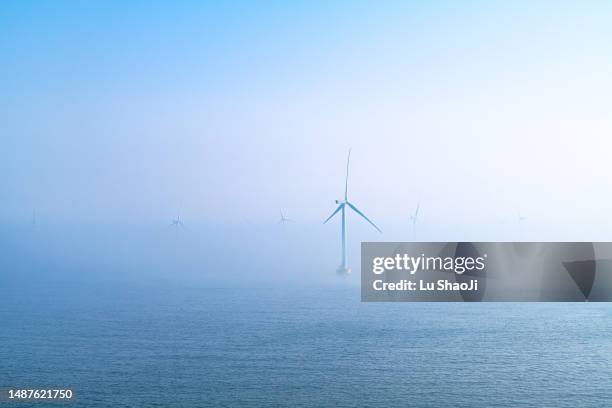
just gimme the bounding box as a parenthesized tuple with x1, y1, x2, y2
(0, 1, 612, 240)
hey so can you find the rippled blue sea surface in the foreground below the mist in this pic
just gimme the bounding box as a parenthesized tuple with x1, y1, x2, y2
(0, 284, 612, 408)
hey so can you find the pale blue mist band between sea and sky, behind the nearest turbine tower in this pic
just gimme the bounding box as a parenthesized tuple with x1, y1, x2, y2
(0, 213, 605, 287)
